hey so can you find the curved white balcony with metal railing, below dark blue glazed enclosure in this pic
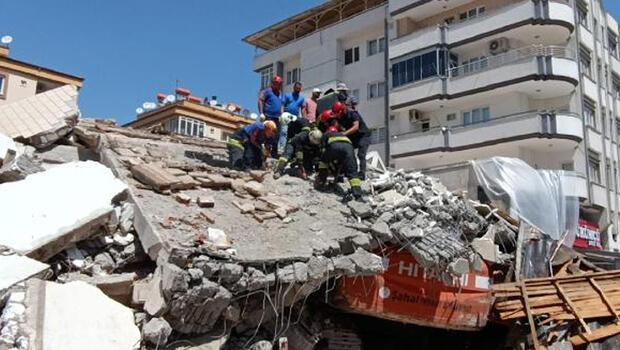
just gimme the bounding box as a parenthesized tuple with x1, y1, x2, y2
(390, 45, 579, 110)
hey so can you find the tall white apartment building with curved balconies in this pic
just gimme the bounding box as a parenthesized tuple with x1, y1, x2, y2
(245, 0, 620, 250)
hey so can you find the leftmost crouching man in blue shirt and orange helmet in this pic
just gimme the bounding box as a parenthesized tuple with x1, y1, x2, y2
(226, 120, 278, 170)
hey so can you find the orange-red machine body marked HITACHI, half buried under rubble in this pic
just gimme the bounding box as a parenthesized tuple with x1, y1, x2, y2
(332, 249, 493, 331)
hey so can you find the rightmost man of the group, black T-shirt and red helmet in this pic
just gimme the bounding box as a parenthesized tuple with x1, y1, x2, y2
(332, 101, 370, 180)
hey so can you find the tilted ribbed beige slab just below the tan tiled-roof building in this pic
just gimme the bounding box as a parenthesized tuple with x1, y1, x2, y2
(0, 85, 80, 147)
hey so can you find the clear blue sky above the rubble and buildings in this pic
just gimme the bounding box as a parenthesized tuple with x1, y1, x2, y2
(0, 0, 620, 123)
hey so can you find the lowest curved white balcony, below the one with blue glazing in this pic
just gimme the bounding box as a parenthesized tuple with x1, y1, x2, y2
(392, 111, 583, 158)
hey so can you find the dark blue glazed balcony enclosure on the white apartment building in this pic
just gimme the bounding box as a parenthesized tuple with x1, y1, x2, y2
(392, 50, 446, 87)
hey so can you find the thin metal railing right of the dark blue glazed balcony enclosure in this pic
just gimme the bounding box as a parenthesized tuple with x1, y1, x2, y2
(449, 45, 576, 78)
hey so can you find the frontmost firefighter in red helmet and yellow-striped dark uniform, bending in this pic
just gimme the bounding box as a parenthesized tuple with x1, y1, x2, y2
(315, 110, 362, 200)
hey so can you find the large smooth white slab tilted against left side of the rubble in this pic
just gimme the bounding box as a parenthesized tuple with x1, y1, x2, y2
(0, 161, 127, 260)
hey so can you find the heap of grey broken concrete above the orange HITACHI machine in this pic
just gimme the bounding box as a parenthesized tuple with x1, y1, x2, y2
(360, 170, 496, 281)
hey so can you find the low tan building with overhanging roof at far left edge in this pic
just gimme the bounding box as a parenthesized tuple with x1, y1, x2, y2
(0, 45, 84, 105)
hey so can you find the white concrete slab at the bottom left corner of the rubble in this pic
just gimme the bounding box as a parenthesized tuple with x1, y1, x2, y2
(25, 279, 141, 350)
